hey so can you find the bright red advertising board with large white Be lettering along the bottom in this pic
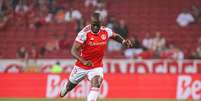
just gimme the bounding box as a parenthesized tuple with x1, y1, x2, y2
(0, 73, 201, 100)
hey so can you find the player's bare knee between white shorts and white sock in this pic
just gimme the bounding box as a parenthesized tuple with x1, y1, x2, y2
(91, 76, 103, 88)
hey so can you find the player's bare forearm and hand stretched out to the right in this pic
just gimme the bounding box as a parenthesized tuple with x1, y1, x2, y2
(111, 32, 133, 48)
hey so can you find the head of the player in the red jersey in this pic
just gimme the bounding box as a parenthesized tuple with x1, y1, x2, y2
(91, 12, 101, 33)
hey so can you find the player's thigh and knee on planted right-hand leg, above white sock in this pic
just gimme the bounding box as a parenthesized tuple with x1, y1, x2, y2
(87, 68, 103, 88)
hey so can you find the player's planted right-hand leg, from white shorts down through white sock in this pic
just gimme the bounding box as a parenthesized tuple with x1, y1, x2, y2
(87, 68, 103, 101)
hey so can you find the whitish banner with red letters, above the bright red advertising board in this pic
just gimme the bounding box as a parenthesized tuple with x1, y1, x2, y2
(0, 59, 201, 74)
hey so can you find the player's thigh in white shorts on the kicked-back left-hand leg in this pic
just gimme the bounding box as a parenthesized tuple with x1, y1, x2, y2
(69, 66, 87, 84)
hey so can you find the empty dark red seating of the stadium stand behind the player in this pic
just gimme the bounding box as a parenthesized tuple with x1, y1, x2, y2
(0, 0, 201, 58)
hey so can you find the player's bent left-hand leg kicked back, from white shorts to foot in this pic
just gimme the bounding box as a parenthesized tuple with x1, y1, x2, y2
(60, 66, 87, 97)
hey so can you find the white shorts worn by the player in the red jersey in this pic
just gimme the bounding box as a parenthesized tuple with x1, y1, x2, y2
(69, 66, 103, 84)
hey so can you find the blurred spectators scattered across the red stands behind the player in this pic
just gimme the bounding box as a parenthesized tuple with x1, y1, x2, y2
(0, 0, 201, 60)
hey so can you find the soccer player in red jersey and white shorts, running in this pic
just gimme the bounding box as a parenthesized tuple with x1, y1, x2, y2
(60, 13, 132, 101)
